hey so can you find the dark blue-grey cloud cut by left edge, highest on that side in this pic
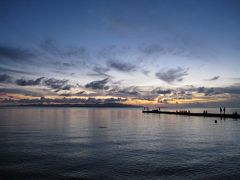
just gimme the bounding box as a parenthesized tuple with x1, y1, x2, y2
(0, 45, 35, 61)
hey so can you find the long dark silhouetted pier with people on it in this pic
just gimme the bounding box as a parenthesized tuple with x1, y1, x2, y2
(142, 108, 240, 119)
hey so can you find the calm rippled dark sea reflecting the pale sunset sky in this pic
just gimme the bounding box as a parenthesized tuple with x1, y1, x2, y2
(0, 108, 240, 179)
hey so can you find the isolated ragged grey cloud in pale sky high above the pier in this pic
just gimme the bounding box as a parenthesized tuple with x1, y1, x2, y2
(156, 67, 188, 83)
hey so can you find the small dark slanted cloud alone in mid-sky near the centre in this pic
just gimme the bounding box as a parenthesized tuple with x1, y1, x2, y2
(108, 60, 136, 72)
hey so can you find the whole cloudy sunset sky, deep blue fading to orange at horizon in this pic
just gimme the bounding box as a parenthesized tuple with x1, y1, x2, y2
(0, 0, 240, 107)
